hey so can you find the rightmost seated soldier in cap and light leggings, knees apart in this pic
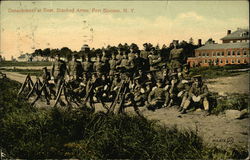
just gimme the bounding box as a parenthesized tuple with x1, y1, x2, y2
(181, 75, 209, 114)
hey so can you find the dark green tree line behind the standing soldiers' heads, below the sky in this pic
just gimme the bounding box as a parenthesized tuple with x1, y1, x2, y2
(31, 39, 199, 62)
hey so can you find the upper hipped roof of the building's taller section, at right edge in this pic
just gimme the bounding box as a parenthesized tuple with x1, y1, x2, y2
(221, 28, 249, 40)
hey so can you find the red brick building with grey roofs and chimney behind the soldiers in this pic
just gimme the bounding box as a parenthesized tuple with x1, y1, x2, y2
(187, 28, 249, 67)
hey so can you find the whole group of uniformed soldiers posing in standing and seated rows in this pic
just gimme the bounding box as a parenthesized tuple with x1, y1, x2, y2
(35, 44, 209, 114)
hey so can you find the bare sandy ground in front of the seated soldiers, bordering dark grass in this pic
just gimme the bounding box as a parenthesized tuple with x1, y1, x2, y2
(143, 108, 249, 148)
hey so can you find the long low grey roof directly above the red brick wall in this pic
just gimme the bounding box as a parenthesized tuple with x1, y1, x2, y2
(196, 42, 249, 50)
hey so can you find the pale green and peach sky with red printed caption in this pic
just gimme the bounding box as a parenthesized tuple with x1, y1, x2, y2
(0, 0, 249, 59)
